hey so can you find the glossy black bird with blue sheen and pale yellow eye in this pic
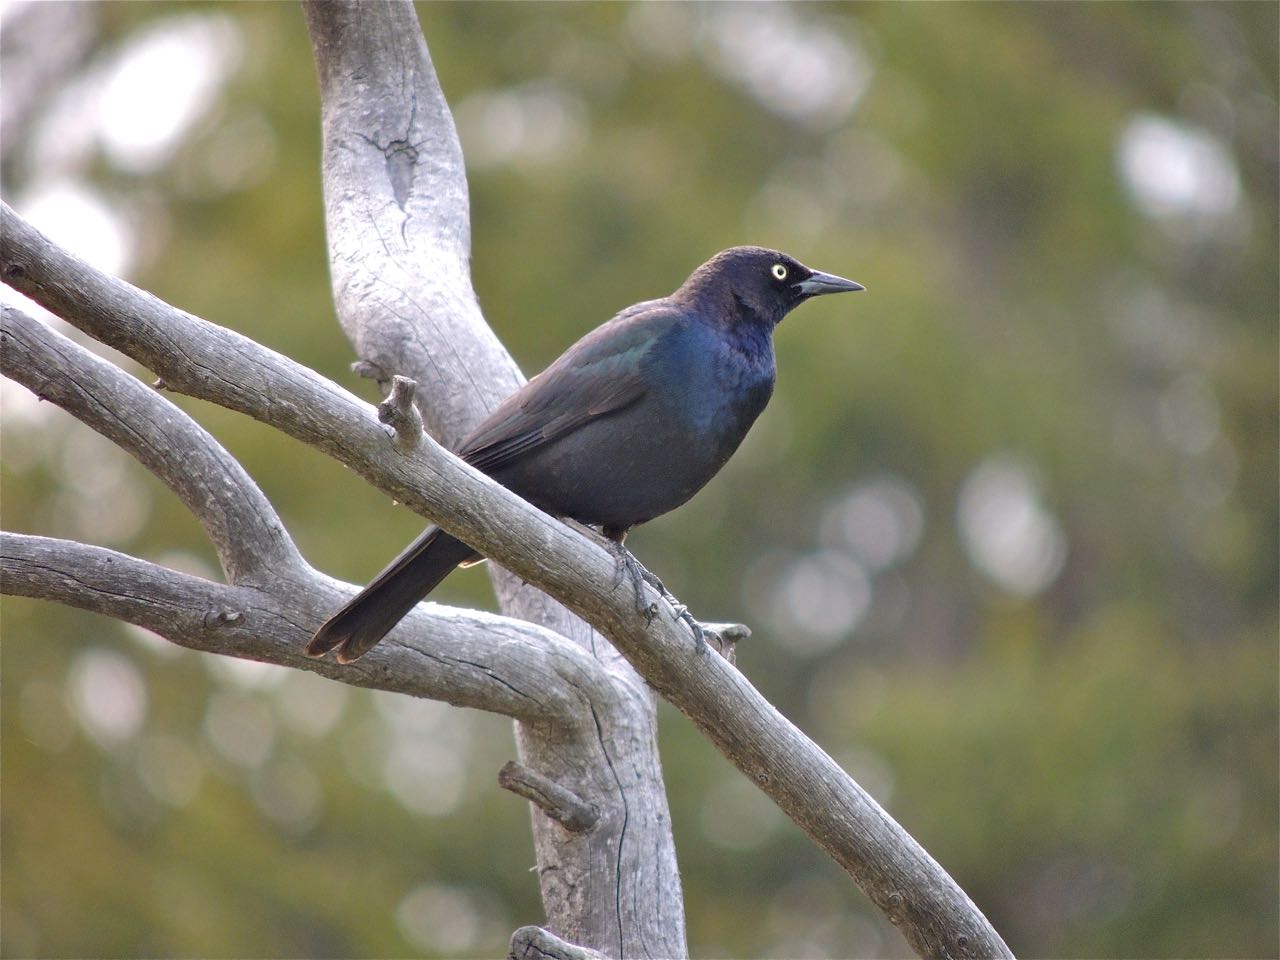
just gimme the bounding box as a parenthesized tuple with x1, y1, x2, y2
(306, 247, 864, 663)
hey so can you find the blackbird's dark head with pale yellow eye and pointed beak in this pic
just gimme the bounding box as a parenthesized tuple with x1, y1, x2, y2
(676, 247, 865, 324)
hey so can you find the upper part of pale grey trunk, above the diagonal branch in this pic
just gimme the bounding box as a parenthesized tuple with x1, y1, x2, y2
(303, 1, 524, 448)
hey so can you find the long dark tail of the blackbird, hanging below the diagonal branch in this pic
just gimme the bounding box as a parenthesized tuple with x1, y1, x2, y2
(306, 526, 479, 663)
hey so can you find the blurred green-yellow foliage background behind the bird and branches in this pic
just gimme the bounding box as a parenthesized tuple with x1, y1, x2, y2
(0, 3, 1280, 956)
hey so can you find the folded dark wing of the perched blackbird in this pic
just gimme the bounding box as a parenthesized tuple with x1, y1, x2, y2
(458, 301, 678, 472)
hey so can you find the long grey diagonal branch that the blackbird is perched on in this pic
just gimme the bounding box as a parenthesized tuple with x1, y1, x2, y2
(0, 200, 1010, 957)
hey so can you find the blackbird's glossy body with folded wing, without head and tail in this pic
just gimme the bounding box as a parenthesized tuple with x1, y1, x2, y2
(460, 298, 773, 529)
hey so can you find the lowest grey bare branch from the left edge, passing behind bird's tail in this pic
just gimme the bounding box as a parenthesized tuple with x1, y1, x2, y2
(0, 532, 616, 730)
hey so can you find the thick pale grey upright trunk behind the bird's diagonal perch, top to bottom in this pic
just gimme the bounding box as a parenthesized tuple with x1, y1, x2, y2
(298, 0, 687, 957)
